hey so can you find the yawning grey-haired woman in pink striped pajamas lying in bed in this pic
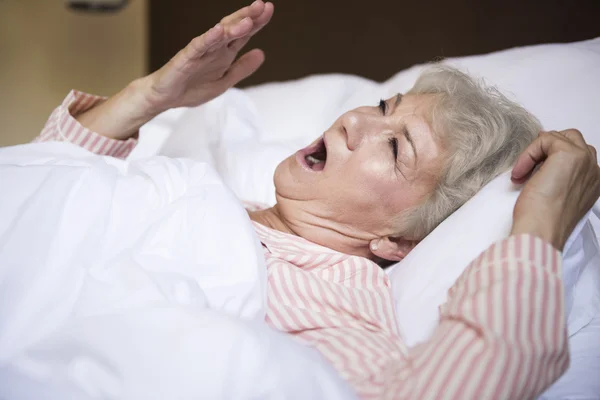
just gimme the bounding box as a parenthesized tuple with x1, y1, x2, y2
(32, 0, 600, 399)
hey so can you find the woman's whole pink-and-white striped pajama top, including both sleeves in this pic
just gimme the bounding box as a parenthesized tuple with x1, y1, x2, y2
(35, 91, 569, 400)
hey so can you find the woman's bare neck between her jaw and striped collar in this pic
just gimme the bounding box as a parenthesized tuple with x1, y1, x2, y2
(248, 204, 374, 259)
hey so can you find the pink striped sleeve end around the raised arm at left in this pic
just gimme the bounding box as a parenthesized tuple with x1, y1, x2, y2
(33, 90, 137, 158)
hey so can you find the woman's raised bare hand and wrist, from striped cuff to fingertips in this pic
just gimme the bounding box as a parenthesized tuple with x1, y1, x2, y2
(75, 0, 273, 140)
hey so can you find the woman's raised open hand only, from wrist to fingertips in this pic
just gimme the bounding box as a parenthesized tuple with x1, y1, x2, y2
(141, 0, 274, 114)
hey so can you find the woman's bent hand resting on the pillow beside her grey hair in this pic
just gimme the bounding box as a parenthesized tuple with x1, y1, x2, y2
(512, 129, 600, 251)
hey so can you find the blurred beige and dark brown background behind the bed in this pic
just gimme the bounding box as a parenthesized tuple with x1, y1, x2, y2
(0, 0, 600, 146)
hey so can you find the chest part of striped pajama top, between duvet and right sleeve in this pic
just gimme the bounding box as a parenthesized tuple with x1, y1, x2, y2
(246, 222, 405, 392)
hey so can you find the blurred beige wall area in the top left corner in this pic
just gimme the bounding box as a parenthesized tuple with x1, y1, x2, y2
(0, 0, 147, 146)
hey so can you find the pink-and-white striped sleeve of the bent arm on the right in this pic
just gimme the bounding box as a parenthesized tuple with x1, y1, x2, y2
(382, 235, 569, 400)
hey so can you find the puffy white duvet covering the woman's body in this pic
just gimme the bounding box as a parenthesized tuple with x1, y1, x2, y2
(0, 143, 353, 399)
